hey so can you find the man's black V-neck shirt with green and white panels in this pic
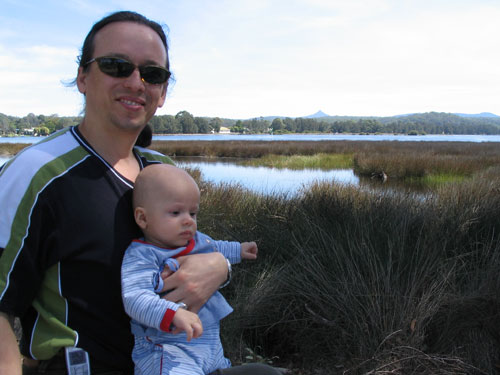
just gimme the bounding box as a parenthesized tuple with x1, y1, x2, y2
(0, 127, 172, 370)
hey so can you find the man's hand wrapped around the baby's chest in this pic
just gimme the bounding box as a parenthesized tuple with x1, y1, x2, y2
(161, 252, 228, 313)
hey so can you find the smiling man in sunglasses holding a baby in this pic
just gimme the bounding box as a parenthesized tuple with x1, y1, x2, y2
(0, 12, 228, 375)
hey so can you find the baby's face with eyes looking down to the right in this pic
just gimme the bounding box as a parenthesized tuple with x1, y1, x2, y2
(143, 182, 200, 248)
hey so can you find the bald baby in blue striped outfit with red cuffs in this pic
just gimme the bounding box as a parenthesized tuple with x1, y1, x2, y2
(122, 164, 257, 375)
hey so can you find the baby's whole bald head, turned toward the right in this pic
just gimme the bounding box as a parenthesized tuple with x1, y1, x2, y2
(133, 164, 200, 248)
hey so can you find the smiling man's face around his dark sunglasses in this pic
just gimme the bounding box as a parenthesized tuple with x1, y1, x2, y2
(77, 22, 167, 132)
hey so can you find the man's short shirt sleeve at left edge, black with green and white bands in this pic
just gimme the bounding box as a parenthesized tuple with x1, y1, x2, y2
(0, 164, 57, 316)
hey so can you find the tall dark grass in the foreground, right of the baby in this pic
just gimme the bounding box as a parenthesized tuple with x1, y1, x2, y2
(192, 169, 500, 374)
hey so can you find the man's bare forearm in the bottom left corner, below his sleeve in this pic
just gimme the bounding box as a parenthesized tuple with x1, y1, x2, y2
(0, 313, 22, 375)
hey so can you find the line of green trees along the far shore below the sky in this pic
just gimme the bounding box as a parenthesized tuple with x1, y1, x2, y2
(0, 111, 500, 136)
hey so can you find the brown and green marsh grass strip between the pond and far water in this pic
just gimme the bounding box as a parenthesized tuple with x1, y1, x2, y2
(152, 141, 500, 188)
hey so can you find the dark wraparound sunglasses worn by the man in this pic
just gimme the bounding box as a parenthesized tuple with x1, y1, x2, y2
(85, 56, 172, 85)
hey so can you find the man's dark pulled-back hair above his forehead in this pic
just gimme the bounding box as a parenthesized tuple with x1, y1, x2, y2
(78, 11, 170, 71)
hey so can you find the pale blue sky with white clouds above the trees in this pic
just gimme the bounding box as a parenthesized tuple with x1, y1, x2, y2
(0, 0, 500, 119)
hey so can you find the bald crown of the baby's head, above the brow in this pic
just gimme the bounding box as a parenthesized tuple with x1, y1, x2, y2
(133, 164, 200, 209)
